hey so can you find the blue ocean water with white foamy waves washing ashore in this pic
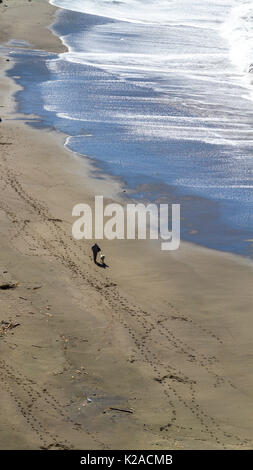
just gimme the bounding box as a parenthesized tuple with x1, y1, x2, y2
(6, 0, 253, 256)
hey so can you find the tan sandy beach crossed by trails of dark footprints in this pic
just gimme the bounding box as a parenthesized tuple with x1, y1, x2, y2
(0, 0, 253, 450)
